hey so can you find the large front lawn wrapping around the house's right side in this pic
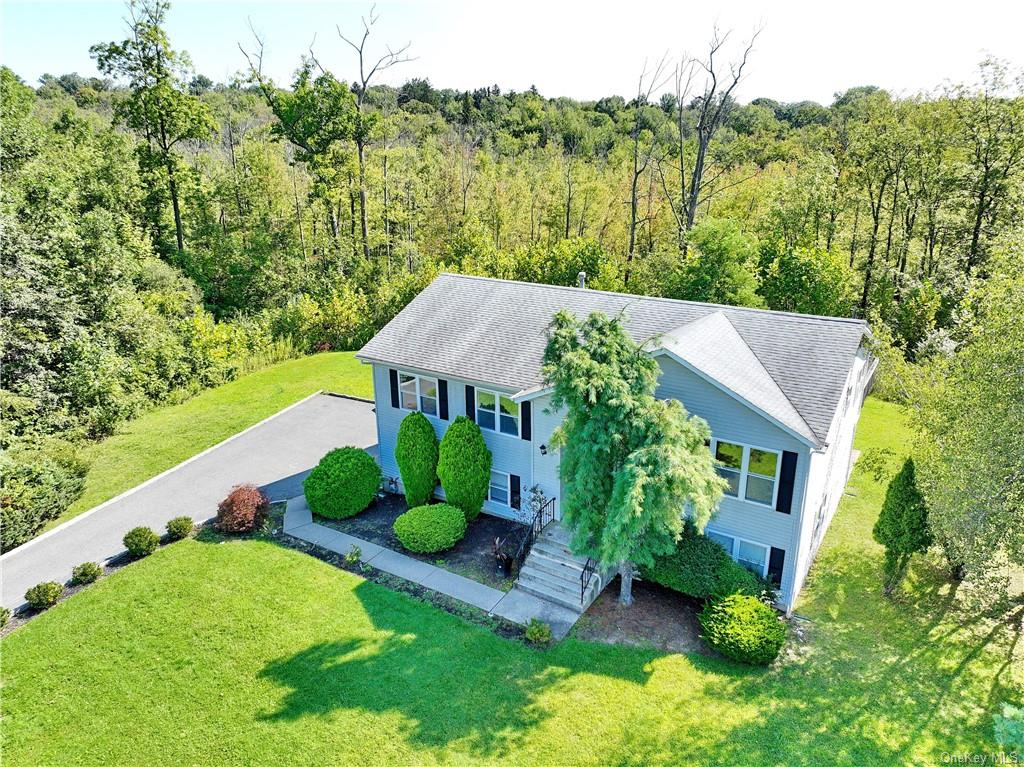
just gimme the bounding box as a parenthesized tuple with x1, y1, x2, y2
(2, 401, 1024, 767)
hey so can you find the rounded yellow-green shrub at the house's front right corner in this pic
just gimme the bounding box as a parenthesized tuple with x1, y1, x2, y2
(700, 594, 785, 666)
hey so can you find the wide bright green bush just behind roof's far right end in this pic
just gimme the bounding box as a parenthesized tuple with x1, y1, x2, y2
(758, 247, 854, 316)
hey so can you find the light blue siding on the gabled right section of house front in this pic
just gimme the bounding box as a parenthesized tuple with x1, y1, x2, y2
(657, 356, 810, 606)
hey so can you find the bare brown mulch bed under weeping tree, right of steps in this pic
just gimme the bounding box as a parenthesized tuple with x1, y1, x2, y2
(573, 578, 713, 654)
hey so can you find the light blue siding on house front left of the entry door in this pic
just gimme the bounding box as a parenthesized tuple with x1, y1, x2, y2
(374, 365, 535, 517)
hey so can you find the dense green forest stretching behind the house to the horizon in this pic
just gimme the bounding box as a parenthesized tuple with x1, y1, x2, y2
(0, 0, 1024, 573)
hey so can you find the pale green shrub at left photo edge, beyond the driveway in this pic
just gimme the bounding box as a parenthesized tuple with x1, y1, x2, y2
(0, 439, 87, 551)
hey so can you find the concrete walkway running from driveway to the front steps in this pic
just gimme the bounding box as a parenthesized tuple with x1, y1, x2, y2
(285, 496, 580, 639)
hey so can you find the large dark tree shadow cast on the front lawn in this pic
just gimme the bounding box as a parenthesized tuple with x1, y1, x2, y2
(260, 583, 688, 760)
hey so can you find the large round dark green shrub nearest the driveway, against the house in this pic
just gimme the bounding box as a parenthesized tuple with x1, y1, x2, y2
(302, 448, 381, 519)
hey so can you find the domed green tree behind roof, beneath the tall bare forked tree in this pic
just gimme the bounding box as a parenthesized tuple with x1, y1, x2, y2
(668, 218, 761, 306)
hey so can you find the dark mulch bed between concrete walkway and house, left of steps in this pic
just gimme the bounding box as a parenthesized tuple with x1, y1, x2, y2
(316, 493, 526, 591)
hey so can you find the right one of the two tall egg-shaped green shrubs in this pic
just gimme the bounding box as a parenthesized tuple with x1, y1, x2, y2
(437, 416, 490, 522)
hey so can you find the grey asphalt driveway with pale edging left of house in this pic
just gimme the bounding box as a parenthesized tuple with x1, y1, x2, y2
(0, 394, 377, 608)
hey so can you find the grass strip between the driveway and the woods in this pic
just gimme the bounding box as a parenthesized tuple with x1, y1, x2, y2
(57, 351, 373, 526)
